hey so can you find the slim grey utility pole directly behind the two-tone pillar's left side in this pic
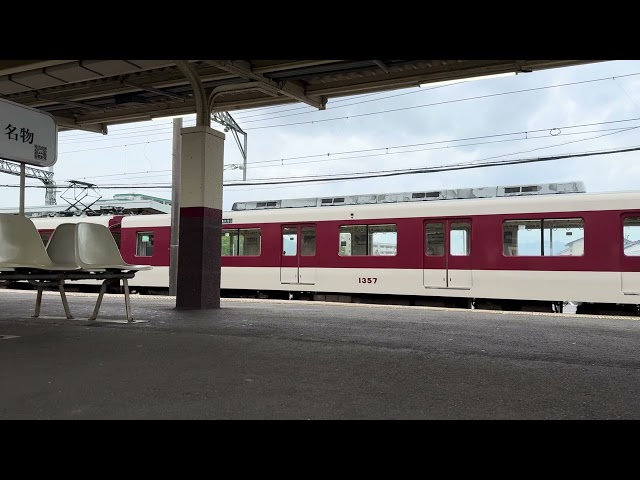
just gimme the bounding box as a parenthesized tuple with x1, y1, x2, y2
(169, 118, 182, 296)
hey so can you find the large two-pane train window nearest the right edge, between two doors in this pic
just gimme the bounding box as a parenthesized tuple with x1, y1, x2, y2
(502, 218, 584, 257)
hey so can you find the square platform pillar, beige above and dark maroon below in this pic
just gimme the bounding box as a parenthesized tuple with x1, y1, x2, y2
(176, 126, 225, 309)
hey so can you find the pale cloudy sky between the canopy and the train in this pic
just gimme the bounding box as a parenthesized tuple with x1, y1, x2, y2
(0, 60, 640, 210)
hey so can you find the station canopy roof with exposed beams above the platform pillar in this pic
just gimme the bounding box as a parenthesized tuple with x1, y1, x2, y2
(0, 60, 594, 134)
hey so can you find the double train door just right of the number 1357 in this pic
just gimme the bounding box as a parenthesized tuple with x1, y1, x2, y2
(422, 218, 473, 290)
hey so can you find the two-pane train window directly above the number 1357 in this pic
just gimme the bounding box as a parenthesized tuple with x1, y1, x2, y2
(338, 224, 398, 256)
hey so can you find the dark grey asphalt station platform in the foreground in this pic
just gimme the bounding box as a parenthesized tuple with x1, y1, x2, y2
(0, 290, 640, 420)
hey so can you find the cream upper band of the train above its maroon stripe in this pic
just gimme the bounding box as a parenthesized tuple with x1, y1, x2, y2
(117, 191, 640, 227)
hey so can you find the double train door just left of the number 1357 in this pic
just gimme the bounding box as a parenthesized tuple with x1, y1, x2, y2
(280, 225, 316, 285)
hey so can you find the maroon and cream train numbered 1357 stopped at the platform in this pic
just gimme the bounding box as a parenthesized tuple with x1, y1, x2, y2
(16, 182, 640, 315)
